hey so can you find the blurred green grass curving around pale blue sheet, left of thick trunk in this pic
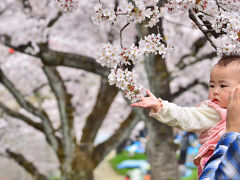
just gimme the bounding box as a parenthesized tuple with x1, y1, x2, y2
(109, 151, 147, 175)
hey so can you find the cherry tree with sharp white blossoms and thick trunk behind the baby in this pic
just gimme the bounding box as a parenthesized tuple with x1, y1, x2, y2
(90, 0, 240, 179)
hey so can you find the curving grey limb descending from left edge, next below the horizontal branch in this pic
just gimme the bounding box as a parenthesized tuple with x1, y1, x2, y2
(0, 69, 59, 152)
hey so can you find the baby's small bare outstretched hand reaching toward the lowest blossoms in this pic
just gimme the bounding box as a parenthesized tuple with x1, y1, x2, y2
(131, 90, 162, 112)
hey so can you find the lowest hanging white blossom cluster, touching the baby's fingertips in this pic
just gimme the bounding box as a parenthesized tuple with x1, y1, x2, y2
(108, 68, 146, 102)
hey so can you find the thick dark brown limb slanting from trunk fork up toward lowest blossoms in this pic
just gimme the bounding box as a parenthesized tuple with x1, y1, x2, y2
(80, 78, 118, 144)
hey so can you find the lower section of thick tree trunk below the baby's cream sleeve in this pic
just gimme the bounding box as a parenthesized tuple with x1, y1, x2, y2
(147, 119, 179, 180)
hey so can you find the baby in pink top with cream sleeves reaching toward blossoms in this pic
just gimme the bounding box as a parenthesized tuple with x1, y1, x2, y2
(131, 56, 240, 176)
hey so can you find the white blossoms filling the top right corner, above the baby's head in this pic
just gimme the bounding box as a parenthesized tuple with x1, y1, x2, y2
(166, 0, 240, 55)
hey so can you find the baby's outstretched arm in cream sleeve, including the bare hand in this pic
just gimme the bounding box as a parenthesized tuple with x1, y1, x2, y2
(131, 90, 220, 132)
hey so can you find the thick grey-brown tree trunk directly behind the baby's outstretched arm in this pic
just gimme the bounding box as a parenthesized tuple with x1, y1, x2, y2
(145, 52, 179, 180)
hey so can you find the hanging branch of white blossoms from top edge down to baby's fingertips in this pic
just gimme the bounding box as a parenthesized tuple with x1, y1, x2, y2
(92, 1, 172, 102)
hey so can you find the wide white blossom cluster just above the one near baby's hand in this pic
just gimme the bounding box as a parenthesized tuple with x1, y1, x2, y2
(97, 34, 172, 68)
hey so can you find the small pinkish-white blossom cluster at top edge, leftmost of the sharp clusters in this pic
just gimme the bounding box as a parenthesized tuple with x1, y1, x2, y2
(56, 0, 78, 12)
